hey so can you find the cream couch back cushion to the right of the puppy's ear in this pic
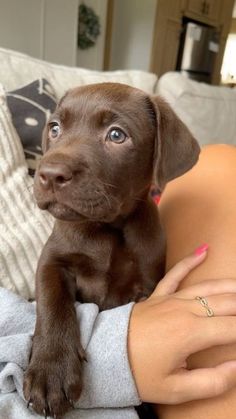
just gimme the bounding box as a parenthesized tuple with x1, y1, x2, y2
(157, 72, 236, 145)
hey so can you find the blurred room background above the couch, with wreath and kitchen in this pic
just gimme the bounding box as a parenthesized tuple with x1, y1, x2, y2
(0, 0, 236, 86)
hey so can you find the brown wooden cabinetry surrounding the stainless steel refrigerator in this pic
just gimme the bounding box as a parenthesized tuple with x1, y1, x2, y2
(150, 0, 234, 84)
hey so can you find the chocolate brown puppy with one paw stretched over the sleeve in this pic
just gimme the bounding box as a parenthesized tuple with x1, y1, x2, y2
(24, 83, 199, 417)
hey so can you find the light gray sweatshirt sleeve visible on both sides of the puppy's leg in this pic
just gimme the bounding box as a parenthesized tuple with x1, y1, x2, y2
(0, 288, 140, 408)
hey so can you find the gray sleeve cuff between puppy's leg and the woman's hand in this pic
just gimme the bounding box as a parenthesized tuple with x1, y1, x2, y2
(78, 303, 140, 408)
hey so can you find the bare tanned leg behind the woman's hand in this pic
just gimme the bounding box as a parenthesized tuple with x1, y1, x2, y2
(157, 145, 236, 419)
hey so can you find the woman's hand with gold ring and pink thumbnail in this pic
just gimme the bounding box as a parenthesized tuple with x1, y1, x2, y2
(128, 247, 236, 404)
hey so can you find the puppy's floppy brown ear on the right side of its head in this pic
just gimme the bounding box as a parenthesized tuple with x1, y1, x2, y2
(150, 96, 200, 190)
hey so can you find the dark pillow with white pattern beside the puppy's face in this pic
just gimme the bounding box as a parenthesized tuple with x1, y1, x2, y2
(7, 79, 56, 173)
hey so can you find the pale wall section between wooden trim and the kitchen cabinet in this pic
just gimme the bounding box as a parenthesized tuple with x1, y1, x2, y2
(110, 0, 157, 70)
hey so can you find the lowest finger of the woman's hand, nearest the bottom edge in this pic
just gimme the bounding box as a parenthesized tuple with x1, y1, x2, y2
(167, 361, 236, 404)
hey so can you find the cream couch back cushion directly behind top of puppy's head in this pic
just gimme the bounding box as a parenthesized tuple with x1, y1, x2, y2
(0, 48, 157, 98)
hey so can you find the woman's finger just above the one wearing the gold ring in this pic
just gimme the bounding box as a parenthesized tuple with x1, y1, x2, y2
(176, 278, 236, 299)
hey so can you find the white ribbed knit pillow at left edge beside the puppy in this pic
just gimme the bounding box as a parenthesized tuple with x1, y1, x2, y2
(0, 85, 53, 299)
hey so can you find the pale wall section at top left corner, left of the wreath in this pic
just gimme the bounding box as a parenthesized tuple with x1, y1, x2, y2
(0, 0, 79, 65)
